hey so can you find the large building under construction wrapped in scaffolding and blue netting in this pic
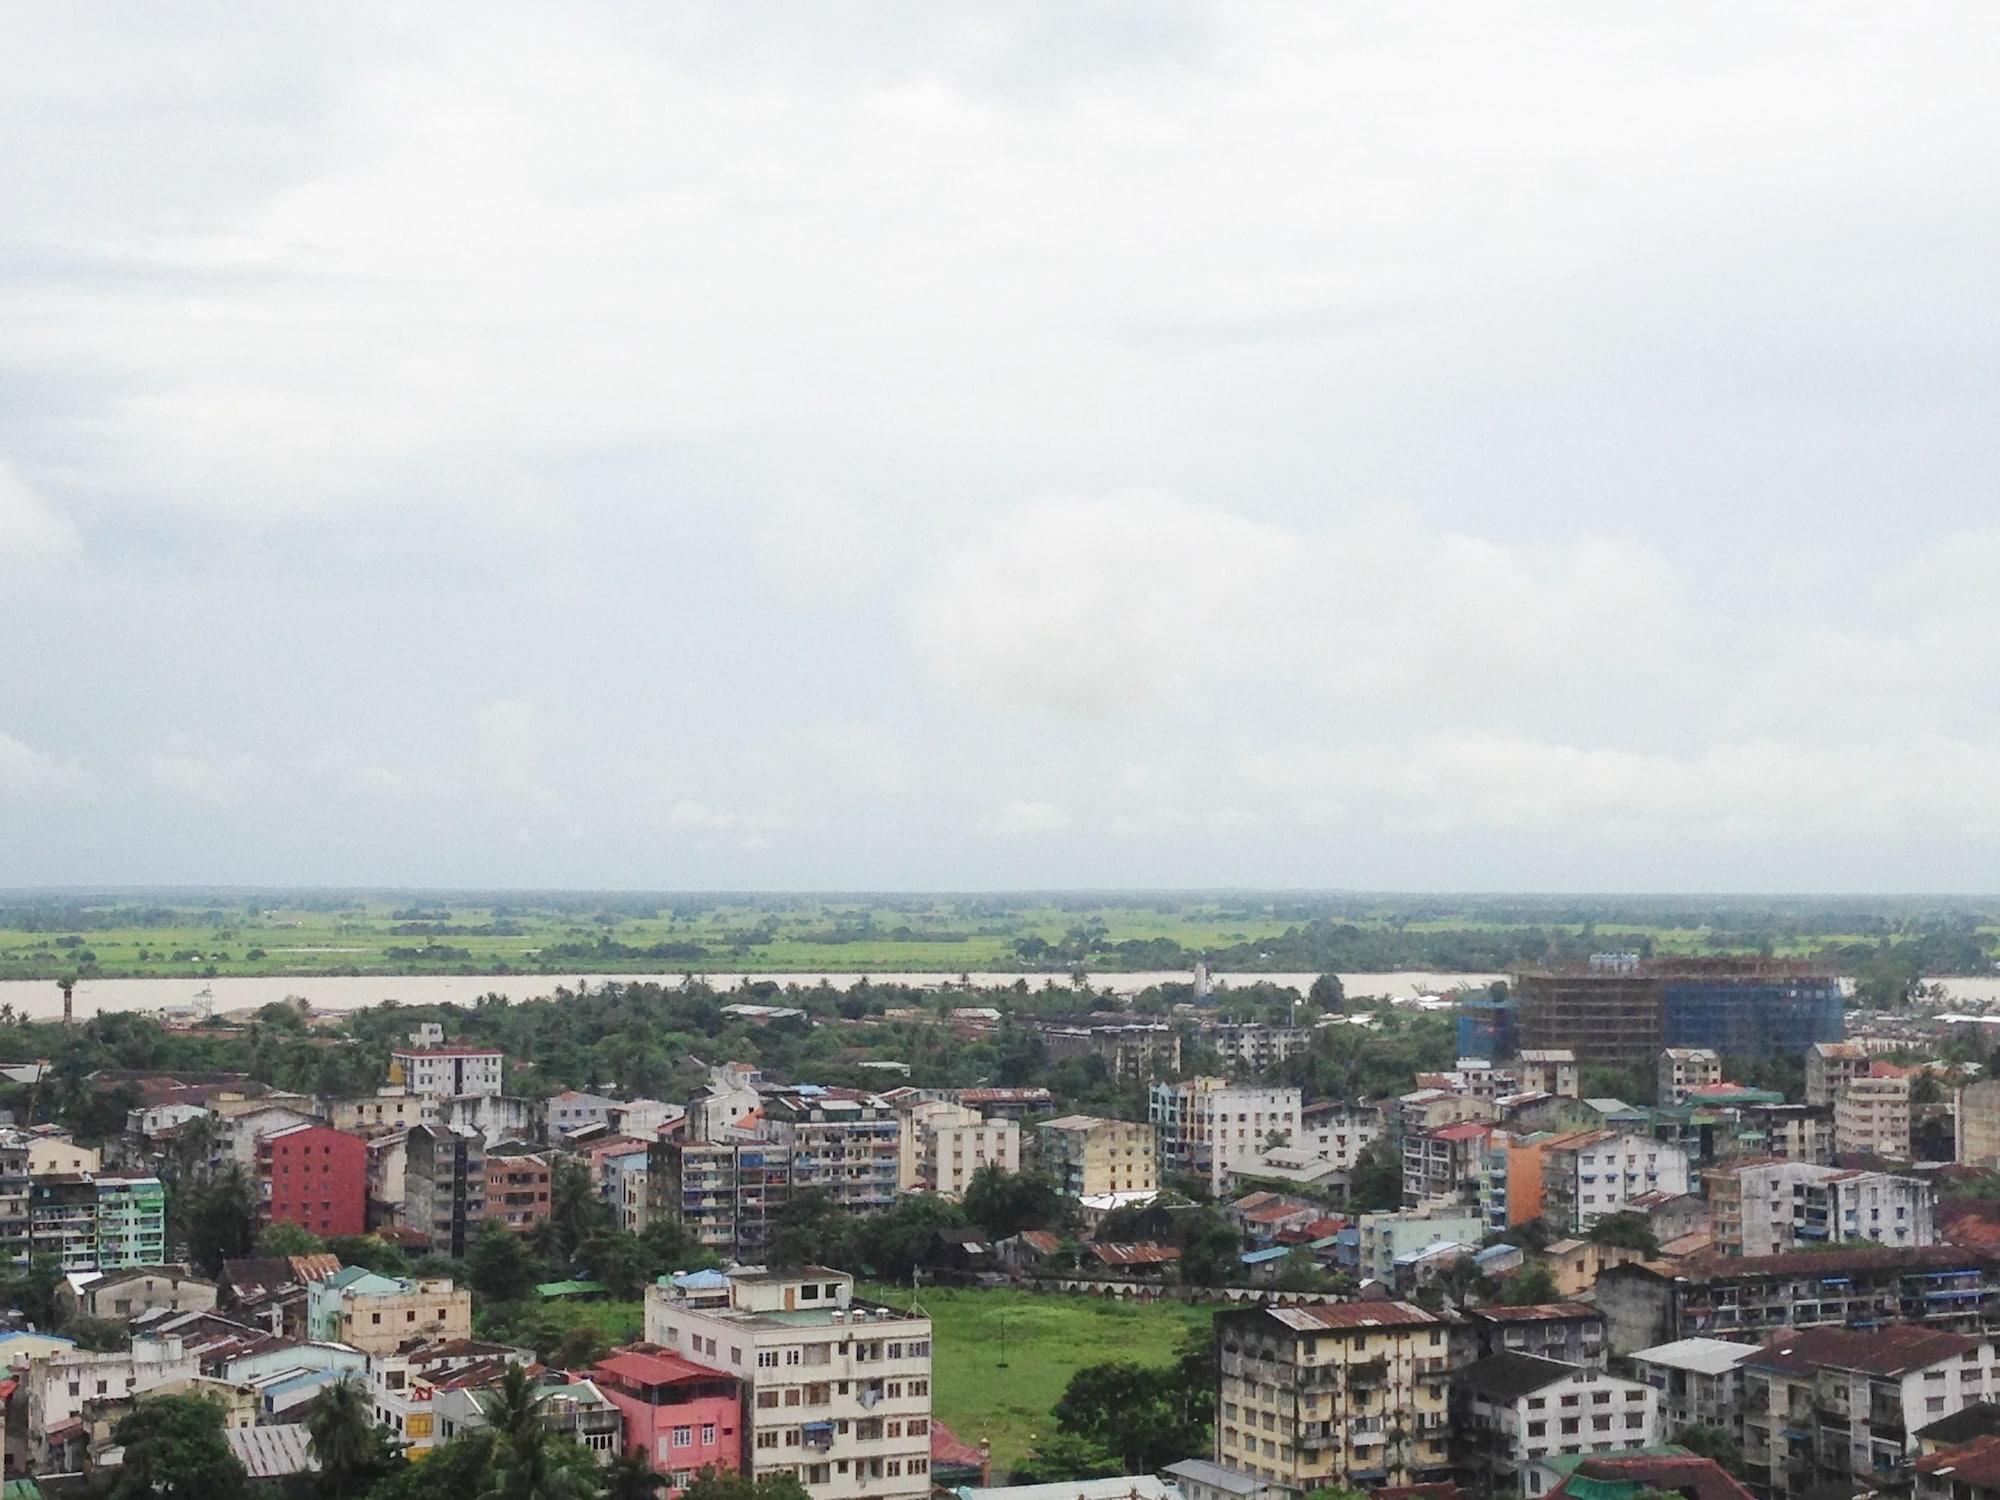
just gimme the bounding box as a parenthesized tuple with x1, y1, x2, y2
(1514, 954, 1844, 1068)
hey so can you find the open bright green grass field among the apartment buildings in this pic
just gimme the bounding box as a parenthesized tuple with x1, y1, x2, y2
(862, 1286, 1214, 1478)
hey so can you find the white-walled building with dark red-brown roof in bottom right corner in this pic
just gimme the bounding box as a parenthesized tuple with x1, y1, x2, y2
(1742, 1324, 1996, 1500)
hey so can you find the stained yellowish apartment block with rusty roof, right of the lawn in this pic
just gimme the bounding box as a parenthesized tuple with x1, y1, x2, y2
(1216, 1302, 1452, 1492)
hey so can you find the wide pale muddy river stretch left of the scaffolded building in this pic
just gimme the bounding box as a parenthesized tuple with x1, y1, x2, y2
(0, 970, 1502, 1016)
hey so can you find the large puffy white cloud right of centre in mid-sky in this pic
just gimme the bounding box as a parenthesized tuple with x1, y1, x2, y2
(910, 492, 1678, 718)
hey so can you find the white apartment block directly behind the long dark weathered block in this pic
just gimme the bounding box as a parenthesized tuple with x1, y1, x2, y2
(1702, 1160, 1938, 1256)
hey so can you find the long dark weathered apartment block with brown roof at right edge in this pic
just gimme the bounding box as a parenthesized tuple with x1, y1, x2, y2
(1596, 1244, 2000, 1354)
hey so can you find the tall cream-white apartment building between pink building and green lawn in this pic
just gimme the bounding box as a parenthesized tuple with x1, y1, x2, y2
(646, 1266, 930, 1500)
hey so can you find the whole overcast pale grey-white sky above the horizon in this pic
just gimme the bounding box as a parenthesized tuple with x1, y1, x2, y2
(0, 0, 2000, 890)
